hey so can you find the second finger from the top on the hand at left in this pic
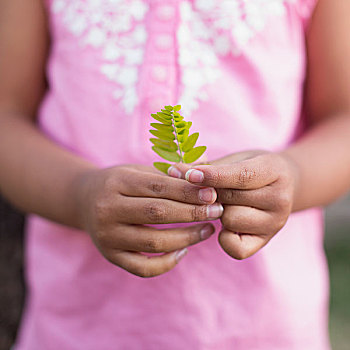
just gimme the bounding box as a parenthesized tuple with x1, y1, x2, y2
(115, 197, 223, 224)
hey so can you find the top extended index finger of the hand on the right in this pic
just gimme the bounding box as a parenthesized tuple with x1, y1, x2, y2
(185, 155, 279, 190)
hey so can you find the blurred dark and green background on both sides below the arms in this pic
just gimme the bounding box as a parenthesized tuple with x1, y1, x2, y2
(0, 196, 350, 350)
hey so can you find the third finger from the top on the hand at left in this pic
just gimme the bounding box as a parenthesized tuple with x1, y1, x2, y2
(109, 224, 215, 253)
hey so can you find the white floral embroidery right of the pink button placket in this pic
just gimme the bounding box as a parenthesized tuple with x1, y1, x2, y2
(177, 0, 288, 115)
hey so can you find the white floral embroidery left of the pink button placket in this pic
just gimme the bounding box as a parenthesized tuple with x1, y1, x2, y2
(52, 0, 148, 114)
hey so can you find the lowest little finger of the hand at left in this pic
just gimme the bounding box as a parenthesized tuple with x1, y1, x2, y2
(109, 248, 187, 278)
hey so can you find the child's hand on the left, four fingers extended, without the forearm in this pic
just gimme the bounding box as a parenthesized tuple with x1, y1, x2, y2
(78, 165, 223, 277)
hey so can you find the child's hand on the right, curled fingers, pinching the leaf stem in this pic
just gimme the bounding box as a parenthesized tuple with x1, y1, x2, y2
(169, 151, 298, 259)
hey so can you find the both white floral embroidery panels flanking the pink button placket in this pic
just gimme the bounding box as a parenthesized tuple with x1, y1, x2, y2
(52, 0, 288, 115)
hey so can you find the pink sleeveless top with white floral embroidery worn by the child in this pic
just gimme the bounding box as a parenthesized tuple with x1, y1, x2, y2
(16, 0, 329, 350)
